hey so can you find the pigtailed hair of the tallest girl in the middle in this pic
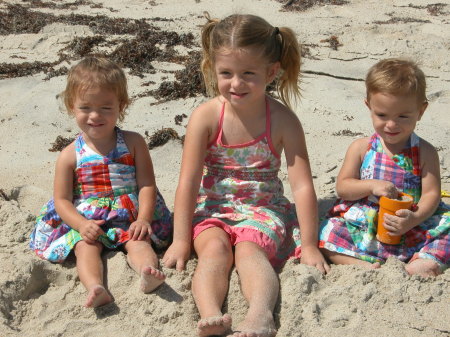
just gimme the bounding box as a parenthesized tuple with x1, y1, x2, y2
(201, 13, 301, 107)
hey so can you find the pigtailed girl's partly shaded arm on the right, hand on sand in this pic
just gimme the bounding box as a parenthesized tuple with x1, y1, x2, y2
(281, 105, 330, 272)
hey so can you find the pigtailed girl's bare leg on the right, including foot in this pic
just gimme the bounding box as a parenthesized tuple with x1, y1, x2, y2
(232, 242, 280, 337)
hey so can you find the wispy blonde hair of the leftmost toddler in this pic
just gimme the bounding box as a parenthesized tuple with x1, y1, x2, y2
(61, 56, 130, 121)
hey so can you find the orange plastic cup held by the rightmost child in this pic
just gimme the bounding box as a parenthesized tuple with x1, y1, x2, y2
(377, 192, 413, 245)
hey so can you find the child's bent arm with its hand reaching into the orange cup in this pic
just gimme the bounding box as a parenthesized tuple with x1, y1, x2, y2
(336, 138, 397, 201)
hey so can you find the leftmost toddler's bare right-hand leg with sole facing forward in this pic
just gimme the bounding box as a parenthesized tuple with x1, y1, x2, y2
(125, 240, 166, 293)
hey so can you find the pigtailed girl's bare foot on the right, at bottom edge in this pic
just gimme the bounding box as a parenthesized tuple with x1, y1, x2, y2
(230, 313, 277, 337)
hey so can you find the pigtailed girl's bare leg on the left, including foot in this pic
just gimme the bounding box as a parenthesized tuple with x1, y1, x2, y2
(192, 227, 233, 337)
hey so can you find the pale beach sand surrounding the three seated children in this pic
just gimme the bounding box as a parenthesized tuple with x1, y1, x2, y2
(0, 0, 450, 337)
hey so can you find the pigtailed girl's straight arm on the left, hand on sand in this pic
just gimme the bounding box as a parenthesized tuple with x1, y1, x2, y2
(163, 101, 214, 270)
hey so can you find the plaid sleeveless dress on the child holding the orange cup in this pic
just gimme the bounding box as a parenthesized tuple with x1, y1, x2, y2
(319, 133, 450, 270)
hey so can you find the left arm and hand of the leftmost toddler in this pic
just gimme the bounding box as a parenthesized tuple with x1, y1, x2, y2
(53, 143, 104, 243)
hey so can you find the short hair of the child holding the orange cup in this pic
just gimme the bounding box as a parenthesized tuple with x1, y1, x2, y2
(366, 58, 427, 103)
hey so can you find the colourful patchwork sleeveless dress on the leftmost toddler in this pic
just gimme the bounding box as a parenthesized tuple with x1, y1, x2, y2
(30, 128, 172, 263)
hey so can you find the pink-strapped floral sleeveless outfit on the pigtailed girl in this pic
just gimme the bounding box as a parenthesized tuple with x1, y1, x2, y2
(193, 102, 300, 268)
